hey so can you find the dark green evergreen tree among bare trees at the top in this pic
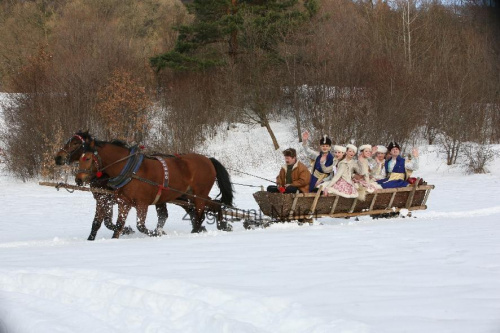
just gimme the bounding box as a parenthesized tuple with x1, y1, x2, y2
(151, 0, 317, 71)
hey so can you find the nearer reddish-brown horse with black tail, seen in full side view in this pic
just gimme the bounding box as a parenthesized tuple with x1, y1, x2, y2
(75, 135, 233, 238)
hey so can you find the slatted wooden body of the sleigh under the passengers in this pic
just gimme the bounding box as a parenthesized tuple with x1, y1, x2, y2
(253, 179, 434, 222)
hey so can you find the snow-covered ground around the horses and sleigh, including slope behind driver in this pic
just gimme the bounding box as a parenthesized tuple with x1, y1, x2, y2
(0, 118, 500, 333)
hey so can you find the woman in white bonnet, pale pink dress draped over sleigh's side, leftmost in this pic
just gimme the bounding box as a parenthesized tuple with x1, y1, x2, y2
(324, 144, 360, 198)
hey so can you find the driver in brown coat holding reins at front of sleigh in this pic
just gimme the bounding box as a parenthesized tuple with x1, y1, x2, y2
(267, 148, 311, 193)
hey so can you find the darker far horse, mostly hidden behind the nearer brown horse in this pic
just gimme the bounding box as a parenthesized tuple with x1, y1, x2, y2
(54, 131, 168, 240)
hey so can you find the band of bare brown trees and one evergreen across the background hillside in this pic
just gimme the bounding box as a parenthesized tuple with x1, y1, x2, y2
(0, 0, 500, 178)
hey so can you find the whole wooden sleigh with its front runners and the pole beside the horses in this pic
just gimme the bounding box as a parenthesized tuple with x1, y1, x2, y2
(39, 179, 434, 229)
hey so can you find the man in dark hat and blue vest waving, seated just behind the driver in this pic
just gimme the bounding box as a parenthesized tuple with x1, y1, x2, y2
(302, 131, 334, 192)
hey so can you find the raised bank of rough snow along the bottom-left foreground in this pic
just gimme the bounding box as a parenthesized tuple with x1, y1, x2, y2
(0, 270, 365, 333)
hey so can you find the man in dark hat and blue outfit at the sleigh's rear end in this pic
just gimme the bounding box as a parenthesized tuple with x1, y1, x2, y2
(377, 141, 418, 188)
